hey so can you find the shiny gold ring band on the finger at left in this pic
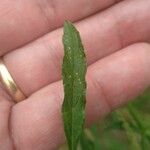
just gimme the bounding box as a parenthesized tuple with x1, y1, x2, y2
(0, 59, 26, 102)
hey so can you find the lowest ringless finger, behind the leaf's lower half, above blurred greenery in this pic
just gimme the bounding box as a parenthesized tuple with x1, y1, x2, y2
(12, 43, 150, 150)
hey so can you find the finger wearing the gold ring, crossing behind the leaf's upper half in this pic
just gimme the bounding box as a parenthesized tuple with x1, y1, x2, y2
(4, 0, 150, 95)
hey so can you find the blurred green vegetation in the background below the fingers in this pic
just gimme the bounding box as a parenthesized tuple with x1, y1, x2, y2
(60, 89, 150, 150)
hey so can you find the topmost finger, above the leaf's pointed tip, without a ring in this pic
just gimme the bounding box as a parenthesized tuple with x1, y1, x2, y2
(0, 0, 120, 55)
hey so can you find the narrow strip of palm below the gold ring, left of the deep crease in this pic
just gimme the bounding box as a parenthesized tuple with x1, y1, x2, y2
(0, 84, 13, 150)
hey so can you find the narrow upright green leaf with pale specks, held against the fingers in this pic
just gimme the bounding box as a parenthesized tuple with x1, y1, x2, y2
(62, 21, 87, 150)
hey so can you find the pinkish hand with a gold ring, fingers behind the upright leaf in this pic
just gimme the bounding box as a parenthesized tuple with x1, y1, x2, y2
(0, 0, 150, 150)
